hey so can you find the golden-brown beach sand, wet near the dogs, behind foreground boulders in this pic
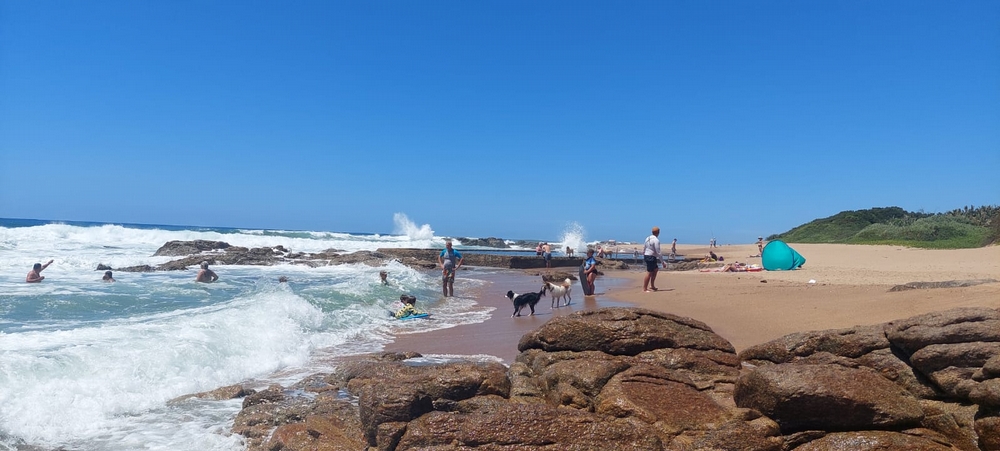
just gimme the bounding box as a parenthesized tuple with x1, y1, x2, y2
(387, 244, 1000, 364)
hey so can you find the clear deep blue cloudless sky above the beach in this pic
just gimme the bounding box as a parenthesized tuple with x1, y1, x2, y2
(0, 0, 1000, 243)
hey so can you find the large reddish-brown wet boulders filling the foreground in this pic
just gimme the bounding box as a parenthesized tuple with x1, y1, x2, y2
(227, 308, 1000, 451)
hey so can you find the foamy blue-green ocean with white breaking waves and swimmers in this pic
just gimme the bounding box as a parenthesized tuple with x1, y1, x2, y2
(0, 214, 586, 451)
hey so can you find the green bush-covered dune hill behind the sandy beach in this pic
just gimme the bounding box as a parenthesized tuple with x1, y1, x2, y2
(767, 206, 1000, 249)
